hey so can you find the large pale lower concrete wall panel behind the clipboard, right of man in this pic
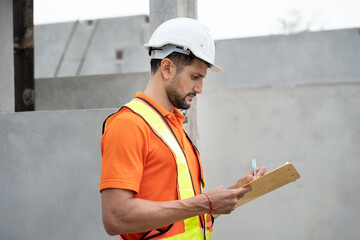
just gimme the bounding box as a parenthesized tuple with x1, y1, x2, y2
(198, 84, 360, 240)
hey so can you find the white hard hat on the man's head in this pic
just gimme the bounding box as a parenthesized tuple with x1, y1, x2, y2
(144, 18, 222, 72)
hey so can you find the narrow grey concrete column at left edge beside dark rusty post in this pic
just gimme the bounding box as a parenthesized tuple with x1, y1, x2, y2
(0, 0, 15, 112)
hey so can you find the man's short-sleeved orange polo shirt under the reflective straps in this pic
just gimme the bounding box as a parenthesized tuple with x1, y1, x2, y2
(100, 92, 203, 227)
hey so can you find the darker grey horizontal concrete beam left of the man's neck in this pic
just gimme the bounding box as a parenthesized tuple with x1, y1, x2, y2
(35, 73, 150, 110)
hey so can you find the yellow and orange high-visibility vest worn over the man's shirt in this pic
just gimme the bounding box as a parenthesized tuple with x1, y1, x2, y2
(116, 97, 212, 240)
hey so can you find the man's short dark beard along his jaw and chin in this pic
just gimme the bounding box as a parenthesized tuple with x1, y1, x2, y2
(165, 75, 196, 110)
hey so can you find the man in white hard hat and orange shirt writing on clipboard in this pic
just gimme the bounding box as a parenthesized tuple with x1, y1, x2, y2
(100, 18, 266, 240)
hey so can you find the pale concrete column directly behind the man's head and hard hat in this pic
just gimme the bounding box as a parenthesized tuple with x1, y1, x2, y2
(149, 0, 199, 146)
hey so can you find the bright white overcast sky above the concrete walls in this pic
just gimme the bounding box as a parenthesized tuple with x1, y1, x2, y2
(34, 0, 360, 39)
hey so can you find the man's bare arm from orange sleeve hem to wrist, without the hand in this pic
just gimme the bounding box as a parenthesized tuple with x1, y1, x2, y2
(102, 189, 209, 235)
